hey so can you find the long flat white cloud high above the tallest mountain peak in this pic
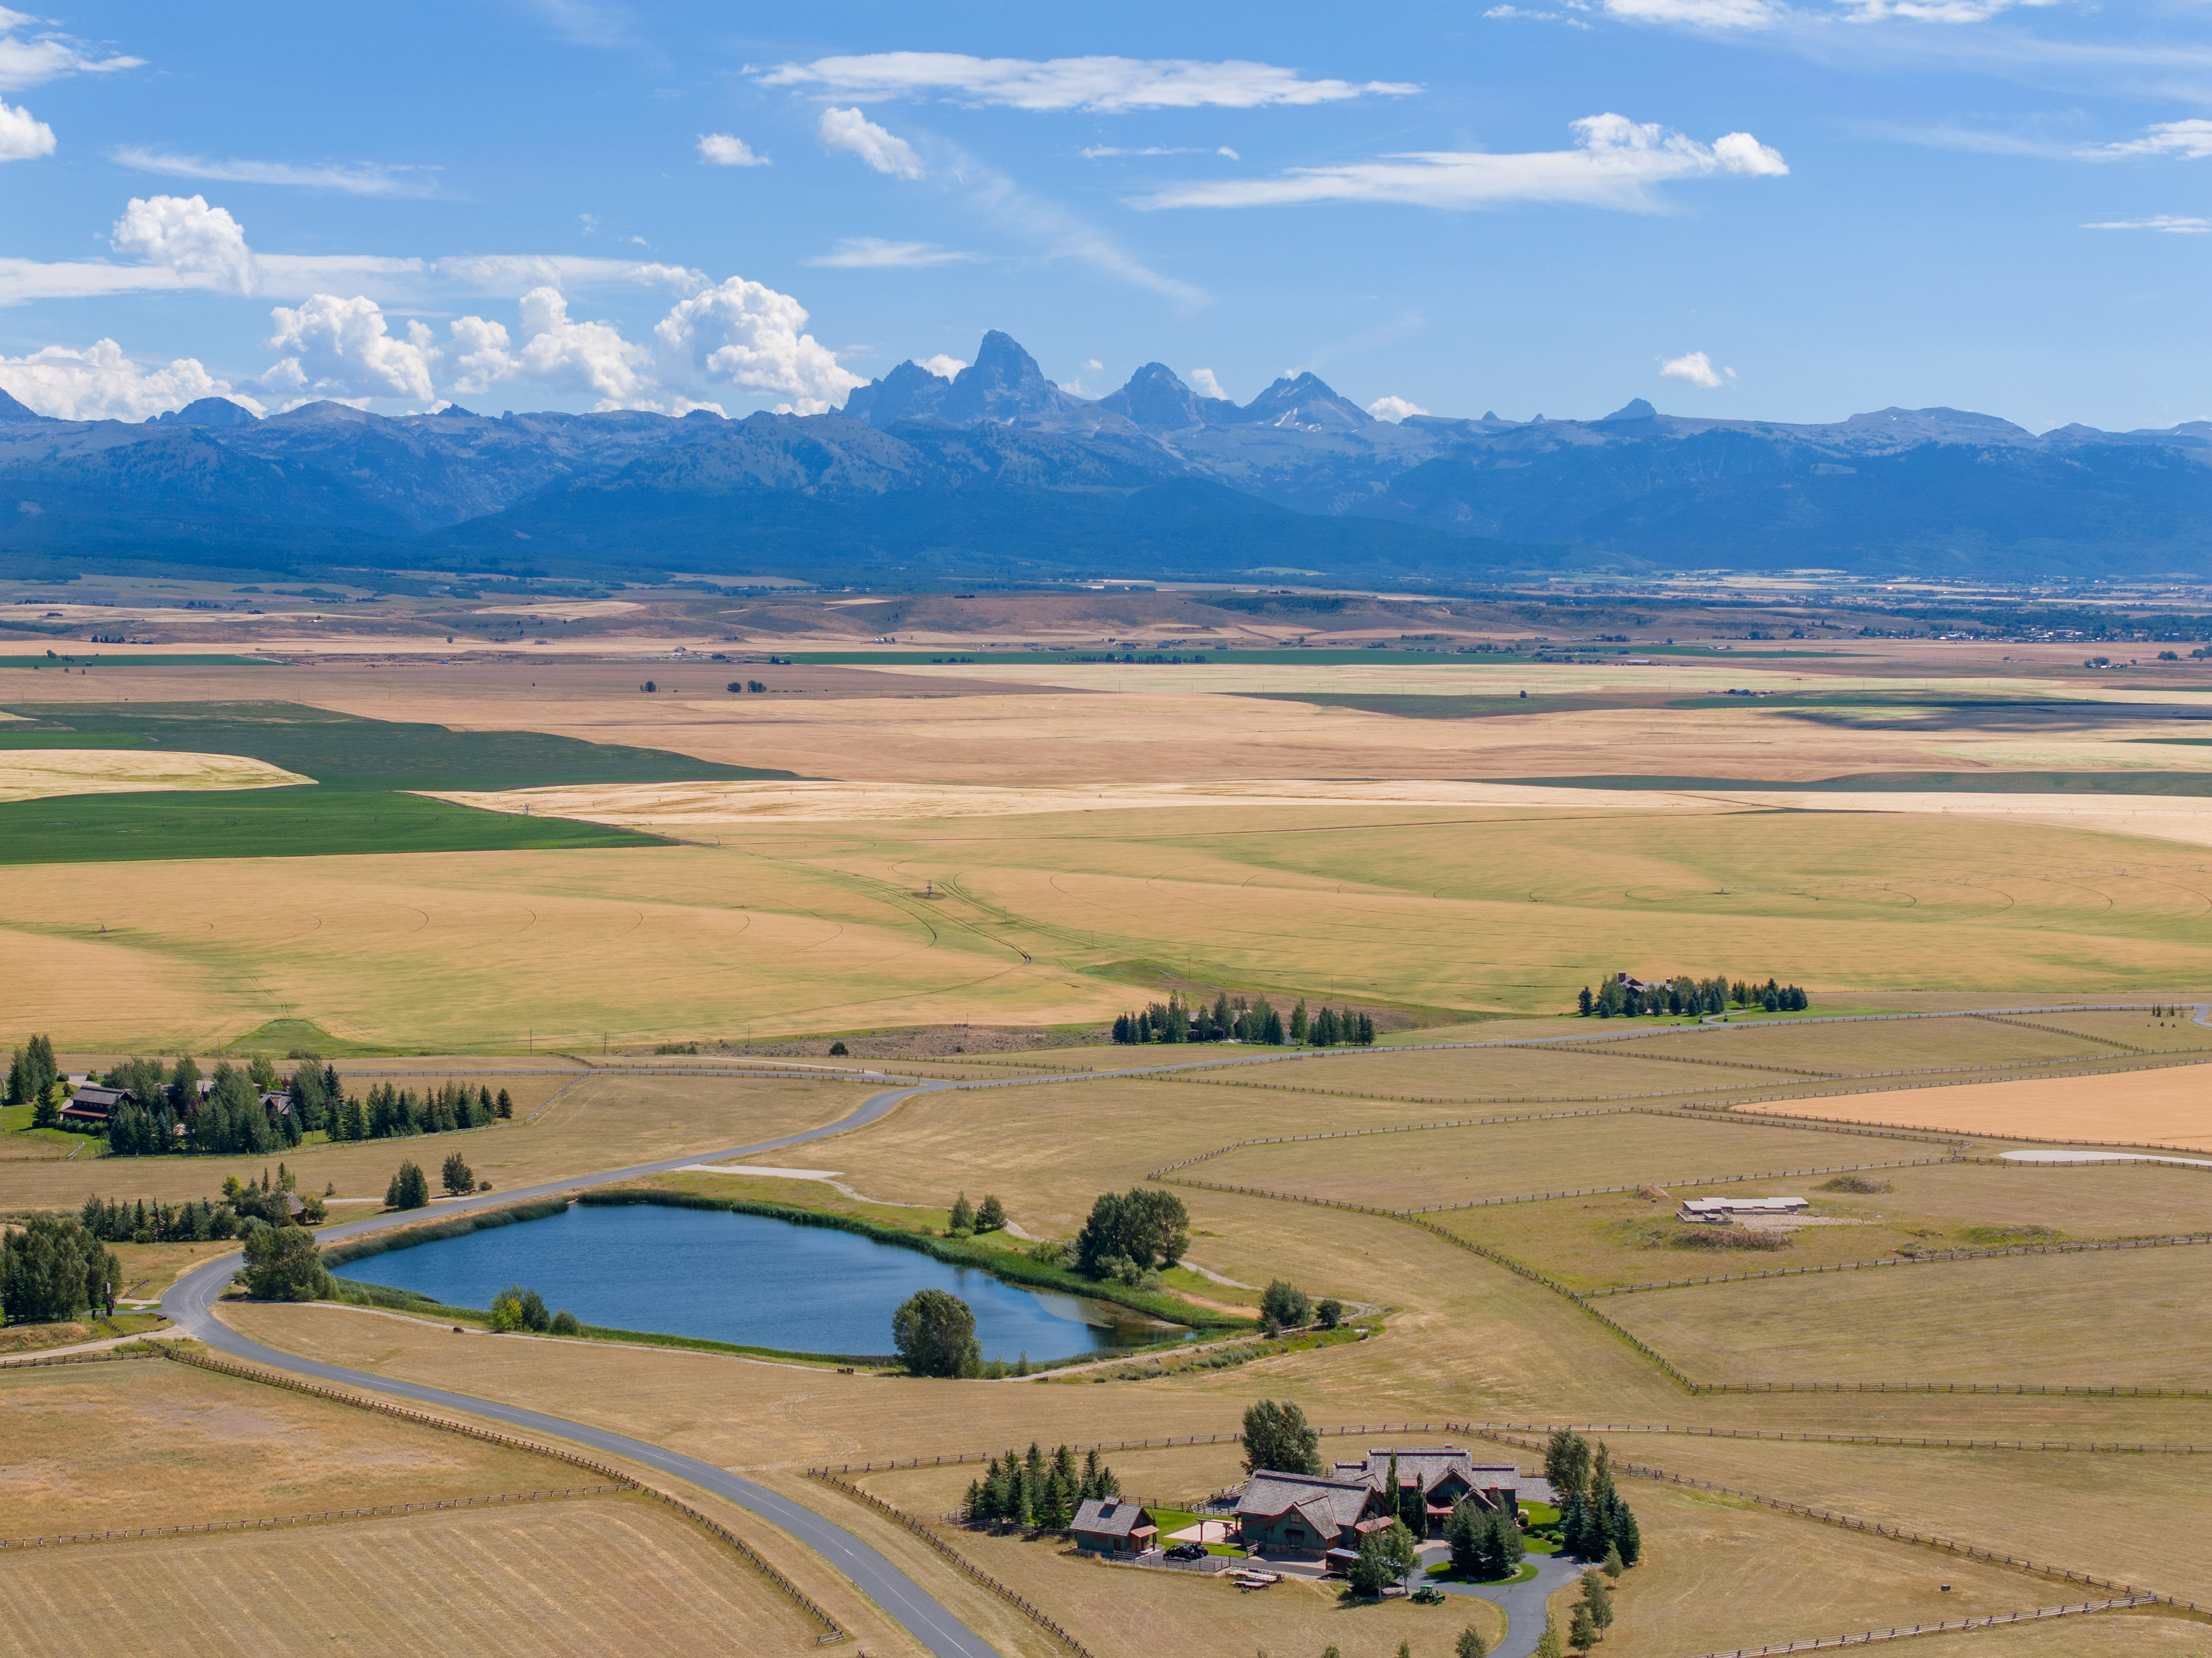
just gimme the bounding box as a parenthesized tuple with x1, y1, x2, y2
(756, 51, 1420, 113)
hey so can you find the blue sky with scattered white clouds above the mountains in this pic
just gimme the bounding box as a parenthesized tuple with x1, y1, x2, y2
(0, 0, 2212, 431)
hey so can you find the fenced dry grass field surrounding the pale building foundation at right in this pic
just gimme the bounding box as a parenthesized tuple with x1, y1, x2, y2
(1438, 1163, 2212, 1289)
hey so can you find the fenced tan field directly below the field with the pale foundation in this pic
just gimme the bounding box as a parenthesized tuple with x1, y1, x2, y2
(1606, 1245, 2212, 1388)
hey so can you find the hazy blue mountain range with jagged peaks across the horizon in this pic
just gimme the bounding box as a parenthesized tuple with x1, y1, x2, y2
(0, 331, 2212, 586)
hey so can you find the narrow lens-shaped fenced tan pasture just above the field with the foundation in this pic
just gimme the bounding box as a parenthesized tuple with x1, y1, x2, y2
(1177, 1112, 1942, 1209)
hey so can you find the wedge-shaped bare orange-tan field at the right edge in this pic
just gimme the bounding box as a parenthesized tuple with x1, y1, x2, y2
(1739, 1065, 2212, 1152)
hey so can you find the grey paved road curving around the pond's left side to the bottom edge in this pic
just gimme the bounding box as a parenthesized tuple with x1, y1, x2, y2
(162, 1085, 998, 1658)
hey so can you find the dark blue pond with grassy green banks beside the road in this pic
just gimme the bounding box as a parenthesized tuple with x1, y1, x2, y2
(339, 1203, 1186, 1364)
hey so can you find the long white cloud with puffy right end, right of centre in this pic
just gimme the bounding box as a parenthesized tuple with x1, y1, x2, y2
(1132, 115, 1789, 210)
